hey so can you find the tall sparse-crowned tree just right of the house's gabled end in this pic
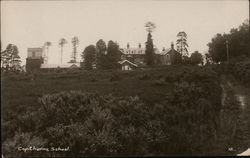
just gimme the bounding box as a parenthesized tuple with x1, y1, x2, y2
(176, 31, 188, 56)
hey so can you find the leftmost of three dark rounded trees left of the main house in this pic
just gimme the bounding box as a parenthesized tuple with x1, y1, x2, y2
(82, 45, 96, 70)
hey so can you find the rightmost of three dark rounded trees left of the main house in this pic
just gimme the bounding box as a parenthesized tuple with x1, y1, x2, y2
(106, 40, 121, 69)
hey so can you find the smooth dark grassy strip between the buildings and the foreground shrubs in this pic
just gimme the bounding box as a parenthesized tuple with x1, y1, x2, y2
(2, 67, 182, 111)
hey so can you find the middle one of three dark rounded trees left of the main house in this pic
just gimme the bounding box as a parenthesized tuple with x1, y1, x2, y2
(96, 39, 107, 69)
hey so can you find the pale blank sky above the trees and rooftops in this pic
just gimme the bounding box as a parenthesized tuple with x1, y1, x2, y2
(1, 0, 249, 65)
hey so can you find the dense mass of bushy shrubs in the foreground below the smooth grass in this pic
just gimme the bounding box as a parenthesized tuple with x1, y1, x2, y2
(3, 87, 222, 156)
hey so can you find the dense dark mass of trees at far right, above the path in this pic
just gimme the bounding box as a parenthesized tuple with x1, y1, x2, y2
(206, 20, 250, 63)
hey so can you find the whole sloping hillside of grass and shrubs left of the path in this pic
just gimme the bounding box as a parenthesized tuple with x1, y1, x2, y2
(2, 66, 224, 156)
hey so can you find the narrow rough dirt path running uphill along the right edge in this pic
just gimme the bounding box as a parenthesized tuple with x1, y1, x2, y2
(221, 76, 250, 154)
